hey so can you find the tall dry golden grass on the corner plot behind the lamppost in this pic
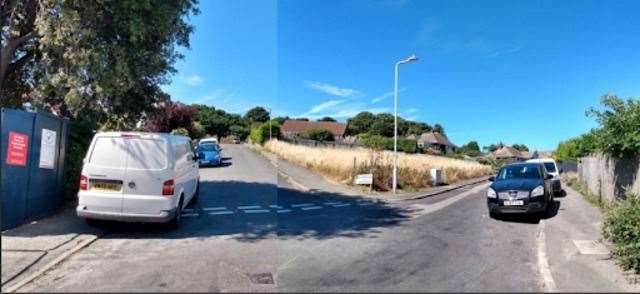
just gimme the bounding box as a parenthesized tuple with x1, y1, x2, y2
(264, 140, 492, 190)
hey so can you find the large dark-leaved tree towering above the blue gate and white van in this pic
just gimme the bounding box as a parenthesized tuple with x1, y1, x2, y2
(30, 0, 198, 130)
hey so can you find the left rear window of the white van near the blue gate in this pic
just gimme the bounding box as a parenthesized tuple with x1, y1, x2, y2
(89, 137, 127, 168)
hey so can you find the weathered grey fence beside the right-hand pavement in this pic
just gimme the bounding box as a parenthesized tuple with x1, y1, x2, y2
(578, 154, 640, 201)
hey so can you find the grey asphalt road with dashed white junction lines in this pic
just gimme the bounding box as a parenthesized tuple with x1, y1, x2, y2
(21, 145, 556, 292)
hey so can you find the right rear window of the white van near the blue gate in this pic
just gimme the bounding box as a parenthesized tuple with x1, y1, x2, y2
(127, 139, 167, 169)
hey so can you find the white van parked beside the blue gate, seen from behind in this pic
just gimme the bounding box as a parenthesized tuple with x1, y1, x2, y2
(76, 132, 200, 225)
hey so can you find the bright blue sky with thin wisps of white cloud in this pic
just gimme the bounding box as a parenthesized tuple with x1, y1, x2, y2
(165, 0, 640, 150)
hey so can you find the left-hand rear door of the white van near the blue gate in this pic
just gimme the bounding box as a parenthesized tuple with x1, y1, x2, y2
(83, 136, 128, 213)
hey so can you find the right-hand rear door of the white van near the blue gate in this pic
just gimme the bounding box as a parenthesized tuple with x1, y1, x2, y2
(122, 135, 173, 214)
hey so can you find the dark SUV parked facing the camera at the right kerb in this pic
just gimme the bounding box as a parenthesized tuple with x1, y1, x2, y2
(487, 162, 553, 217)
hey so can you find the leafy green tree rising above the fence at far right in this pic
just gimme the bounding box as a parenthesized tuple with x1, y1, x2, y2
(587, 95, 640, 157)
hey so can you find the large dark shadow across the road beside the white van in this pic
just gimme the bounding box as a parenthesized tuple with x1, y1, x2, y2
(86, 181, 410, 242)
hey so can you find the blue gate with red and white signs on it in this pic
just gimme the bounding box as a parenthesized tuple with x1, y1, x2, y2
(0, 108, 69, 230)
